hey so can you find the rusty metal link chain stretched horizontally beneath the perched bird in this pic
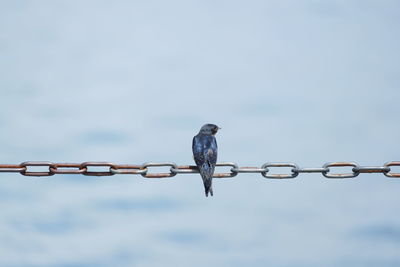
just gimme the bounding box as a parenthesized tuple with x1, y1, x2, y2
(0, 161, 400, 179)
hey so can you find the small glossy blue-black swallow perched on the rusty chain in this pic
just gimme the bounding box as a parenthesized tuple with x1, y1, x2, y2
(192, 124, 221, 197)
